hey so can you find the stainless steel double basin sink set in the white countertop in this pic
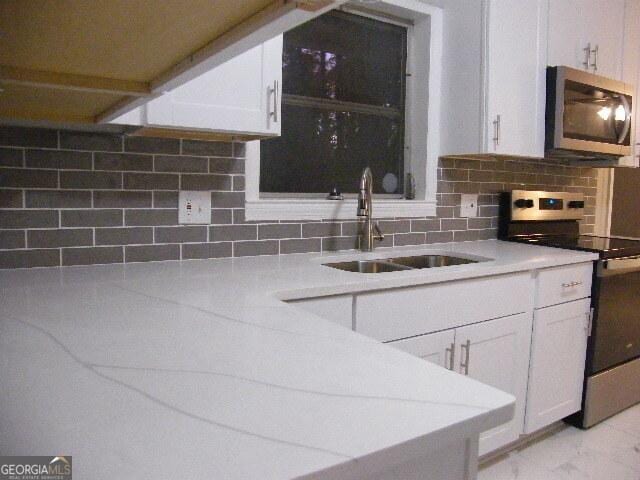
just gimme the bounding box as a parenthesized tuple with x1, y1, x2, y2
(324, 255, 479, 273)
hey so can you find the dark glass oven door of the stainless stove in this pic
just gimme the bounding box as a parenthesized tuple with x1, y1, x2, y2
(588, 257, 640, 374)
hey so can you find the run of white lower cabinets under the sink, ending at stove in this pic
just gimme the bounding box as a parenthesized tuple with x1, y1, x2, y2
(292, 262, 593, 455)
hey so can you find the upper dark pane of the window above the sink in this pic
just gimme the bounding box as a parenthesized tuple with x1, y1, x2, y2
(282, 12, 406, 109)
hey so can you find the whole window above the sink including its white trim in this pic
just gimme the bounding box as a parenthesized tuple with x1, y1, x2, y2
(245, 0, 443, 221)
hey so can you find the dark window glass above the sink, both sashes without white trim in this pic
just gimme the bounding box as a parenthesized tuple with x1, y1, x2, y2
(260, 11, 407, 196)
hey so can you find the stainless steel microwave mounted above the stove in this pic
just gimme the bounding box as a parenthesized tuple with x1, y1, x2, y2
(545, 67, 634, 160)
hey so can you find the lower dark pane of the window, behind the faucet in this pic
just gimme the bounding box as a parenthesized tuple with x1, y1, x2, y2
(260, 105, 404, 194)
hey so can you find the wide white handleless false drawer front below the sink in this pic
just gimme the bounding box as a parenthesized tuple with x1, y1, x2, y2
(355, 273, 531, 342)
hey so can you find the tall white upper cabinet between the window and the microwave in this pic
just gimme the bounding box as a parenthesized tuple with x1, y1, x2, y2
(441, 0, 547, 157)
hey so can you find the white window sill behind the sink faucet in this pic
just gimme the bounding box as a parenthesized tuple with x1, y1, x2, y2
(245, 198, 436, 221)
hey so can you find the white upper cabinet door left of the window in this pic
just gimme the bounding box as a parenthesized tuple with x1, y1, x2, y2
(146, 35, 282, 135)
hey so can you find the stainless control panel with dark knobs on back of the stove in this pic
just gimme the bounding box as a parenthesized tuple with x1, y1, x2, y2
(511, 190, 584, 221)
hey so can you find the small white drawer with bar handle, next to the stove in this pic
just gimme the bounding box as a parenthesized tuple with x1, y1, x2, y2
(535, 262, 593, 308)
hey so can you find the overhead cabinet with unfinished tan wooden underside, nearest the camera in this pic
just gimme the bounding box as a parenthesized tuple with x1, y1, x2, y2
(0, 0, 343, 124)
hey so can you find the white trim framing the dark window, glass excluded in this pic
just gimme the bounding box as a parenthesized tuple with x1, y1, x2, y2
(245, 0, 443, 221)
